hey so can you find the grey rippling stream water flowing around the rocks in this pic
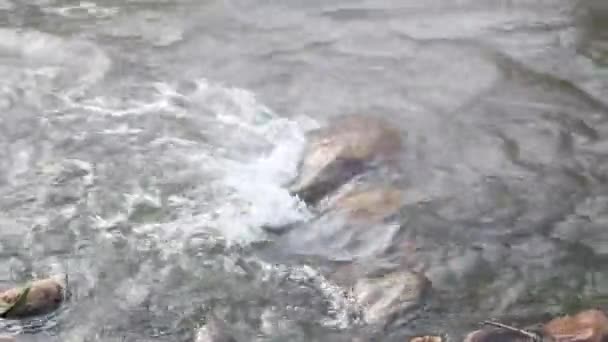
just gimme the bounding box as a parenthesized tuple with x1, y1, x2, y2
(0, 0, 608, 341)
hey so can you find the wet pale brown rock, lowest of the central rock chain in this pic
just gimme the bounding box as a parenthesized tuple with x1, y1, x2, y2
(353, 270, 430, 323)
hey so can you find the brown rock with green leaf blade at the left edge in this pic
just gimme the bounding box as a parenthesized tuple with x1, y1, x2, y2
(0, 278, 64, 319)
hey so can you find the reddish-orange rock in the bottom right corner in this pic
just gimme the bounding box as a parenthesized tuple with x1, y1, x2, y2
(543, 310, 608, 342)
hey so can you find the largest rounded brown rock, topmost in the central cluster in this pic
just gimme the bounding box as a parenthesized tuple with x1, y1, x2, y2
(290, 116, 401, 204)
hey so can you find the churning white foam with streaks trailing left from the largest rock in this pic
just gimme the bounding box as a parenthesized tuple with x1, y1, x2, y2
(83, 79, 316, 243)
